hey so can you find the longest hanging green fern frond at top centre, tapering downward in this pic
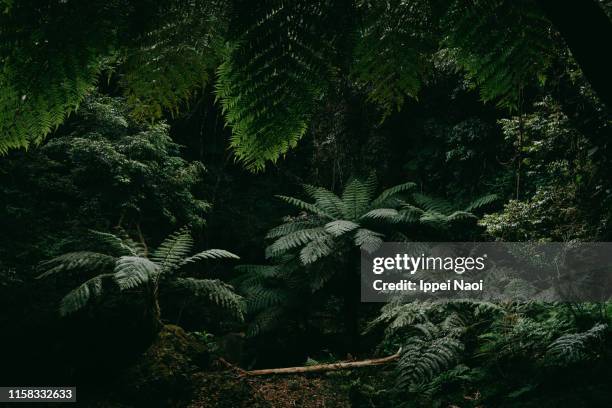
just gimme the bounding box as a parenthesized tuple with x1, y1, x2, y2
(216, 0, 337, 170)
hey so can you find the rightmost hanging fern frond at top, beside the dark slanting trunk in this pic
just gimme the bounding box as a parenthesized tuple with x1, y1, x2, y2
(443, 0, 553, 108)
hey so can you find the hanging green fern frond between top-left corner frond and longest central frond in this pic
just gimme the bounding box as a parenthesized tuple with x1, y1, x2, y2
(120, 0, 225, 119)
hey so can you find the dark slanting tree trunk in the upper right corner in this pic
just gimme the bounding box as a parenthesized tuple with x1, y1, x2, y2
(537, 0, 612, 109)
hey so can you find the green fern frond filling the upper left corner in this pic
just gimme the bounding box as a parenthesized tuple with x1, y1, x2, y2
(0, 1, 124, 153)
